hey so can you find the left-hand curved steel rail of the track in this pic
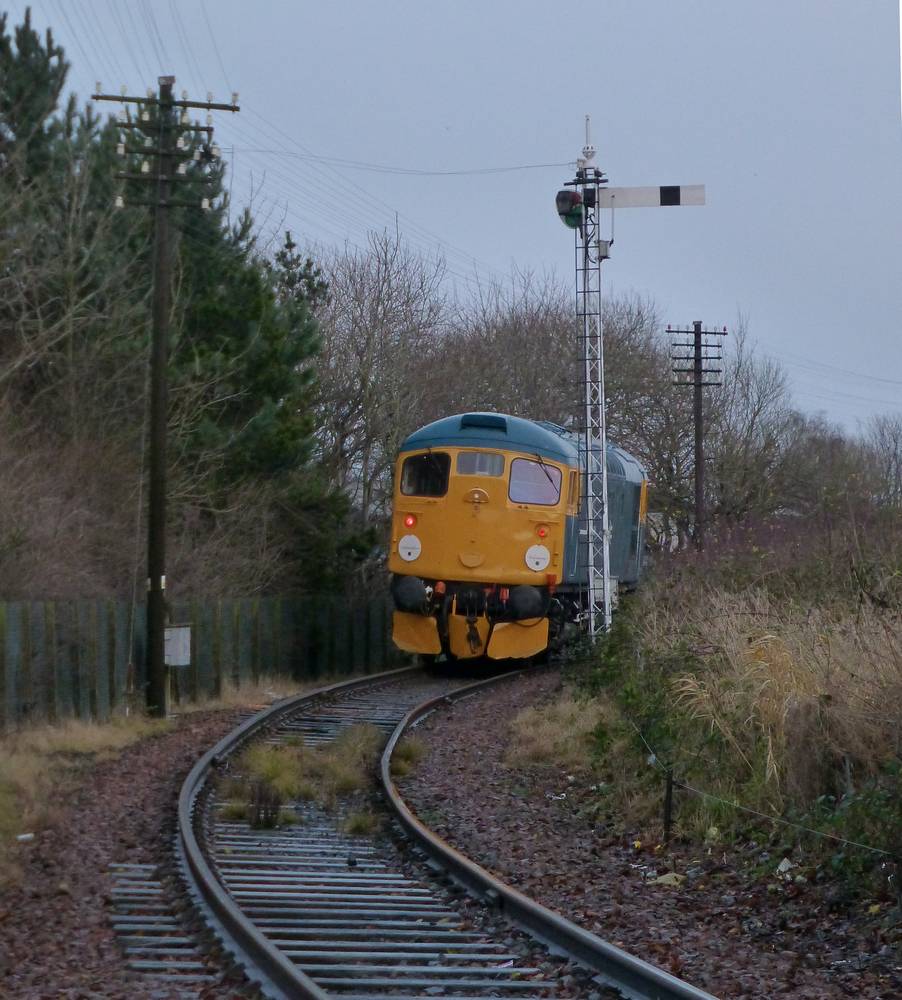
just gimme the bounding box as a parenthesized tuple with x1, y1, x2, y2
(178, 667, 419, 1000)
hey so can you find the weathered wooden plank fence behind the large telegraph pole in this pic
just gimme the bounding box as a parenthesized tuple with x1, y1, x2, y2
(0, 596, 398, 729)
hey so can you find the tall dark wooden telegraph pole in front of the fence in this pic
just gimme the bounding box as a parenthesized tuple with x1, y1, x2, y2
(92, 76, 239, 718)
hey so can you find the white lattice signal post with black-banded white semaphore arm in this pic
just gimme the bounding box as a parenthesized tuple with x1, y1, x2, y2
(555, 115, 705, 640)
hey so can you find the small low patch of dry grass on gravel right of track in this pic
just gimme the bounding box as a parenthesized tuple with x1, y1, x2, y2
(505, 692, 610, 771)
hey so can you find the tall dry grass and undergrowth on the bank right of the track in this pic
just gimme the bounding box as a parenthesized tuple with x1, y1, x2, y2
(549, 512, 902, 871)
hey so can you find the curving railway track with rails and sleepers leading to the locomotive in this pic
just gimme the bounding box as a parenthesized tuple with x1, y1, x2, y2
(159, 670, 712, 1000)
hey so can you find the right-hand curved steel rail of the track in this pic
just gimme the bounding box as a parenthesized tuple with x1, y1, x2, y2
(381, 674, 717, 1000)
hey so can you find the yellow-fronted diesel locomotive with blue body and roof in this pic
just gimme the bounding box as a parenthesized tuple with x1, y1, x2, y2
(388, 413, 648, 662)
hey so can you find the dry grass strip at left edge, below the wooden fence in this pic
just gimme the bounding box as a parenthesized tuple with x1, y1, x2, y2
(0, 716, 169, 885)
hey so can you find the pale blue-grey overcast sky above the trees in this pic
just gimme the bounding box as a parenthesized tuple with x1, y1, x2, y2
(12, 0, 902, 429)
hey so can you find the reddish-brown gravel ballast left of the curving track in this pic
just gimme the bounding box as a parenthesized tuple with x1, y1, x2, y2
(0, 710, 251, 1000)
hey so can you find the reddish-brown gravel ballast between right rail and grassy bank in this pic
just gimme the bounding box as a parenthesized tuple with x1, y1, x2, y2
(398, 673, 902, 1000)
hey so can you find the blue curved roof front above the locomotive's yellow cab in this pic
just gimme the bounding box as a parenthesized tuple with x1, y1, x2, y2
(400, 413, 579, 466)
